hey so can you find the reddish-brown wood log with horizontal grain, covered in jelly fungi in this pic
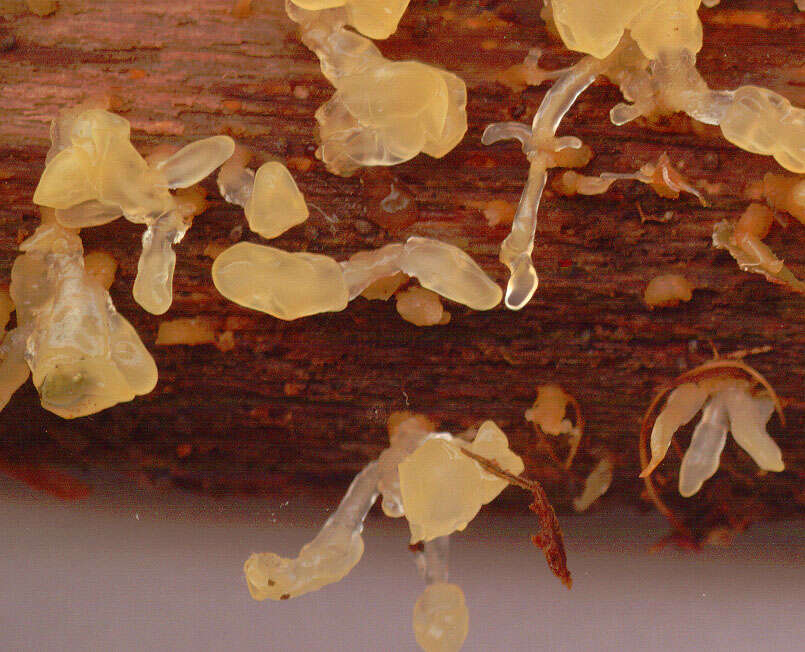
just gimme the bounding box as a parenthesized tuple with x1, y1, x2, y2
(0, 0, 805, 524)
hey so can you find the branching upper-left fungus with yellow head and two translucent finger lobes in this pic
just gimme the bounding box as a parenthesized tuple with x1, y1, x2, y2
(34, 106, 235, 314)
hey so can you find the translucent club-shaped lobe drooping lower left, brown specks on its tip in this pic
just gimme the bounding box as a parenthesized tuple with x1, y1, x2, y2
(243, 462, 379, 600)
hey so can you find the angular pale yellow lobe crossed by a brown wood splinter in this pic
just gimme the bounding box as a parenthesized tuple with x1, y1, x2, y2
(399, 421, 524, 543)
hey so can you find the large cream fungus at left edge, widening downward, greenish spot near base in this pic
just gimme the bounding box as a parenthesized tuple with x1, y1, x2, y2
(0, 221, 157, 418)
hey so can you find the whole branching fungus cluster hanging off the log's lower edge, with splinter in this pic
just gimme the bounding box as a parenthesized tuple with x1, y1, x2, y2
(244, 413, 570, 652)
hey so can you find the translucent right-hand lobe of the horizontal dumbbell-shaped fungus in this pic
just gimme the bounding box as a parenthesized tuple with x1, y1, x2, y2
(400, 236, 503, 310)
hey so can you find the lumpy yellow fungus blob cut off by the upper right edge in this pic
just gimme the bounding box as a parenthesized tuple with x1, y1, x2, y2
(721, 86, 805, 174)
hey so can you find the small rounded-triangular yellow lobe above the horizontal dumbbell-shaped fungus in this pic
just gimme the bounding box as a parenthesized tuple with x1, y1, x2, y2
(244, 161, 309, 238)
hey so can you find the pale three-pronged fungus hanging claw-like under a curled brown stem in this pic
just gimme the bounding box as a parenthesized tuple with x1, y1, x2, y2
(641, 378, 785, 497)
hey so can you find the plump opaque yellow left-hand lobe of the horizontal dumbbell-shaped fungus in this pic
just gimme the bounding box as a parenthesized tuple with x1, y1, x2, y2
(212, 242, 349, 320)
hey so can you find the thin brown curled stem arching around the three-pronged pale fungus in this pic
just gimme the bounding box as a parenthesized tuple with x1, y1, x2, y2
(639, 356, 785, 536)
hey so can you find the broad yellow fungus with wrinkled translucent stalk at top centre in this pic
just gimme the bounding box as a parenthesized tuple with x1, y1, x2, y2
(286, 0, 467, 175)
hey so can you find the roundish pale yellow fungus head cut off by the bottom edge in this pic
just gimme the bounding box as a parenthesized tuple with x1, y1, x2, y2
(413, 582, 470, 652)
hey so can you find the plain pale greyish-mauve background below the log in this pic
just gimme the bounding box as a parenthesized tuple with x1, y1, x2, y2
(0, 477, 805, 652)
